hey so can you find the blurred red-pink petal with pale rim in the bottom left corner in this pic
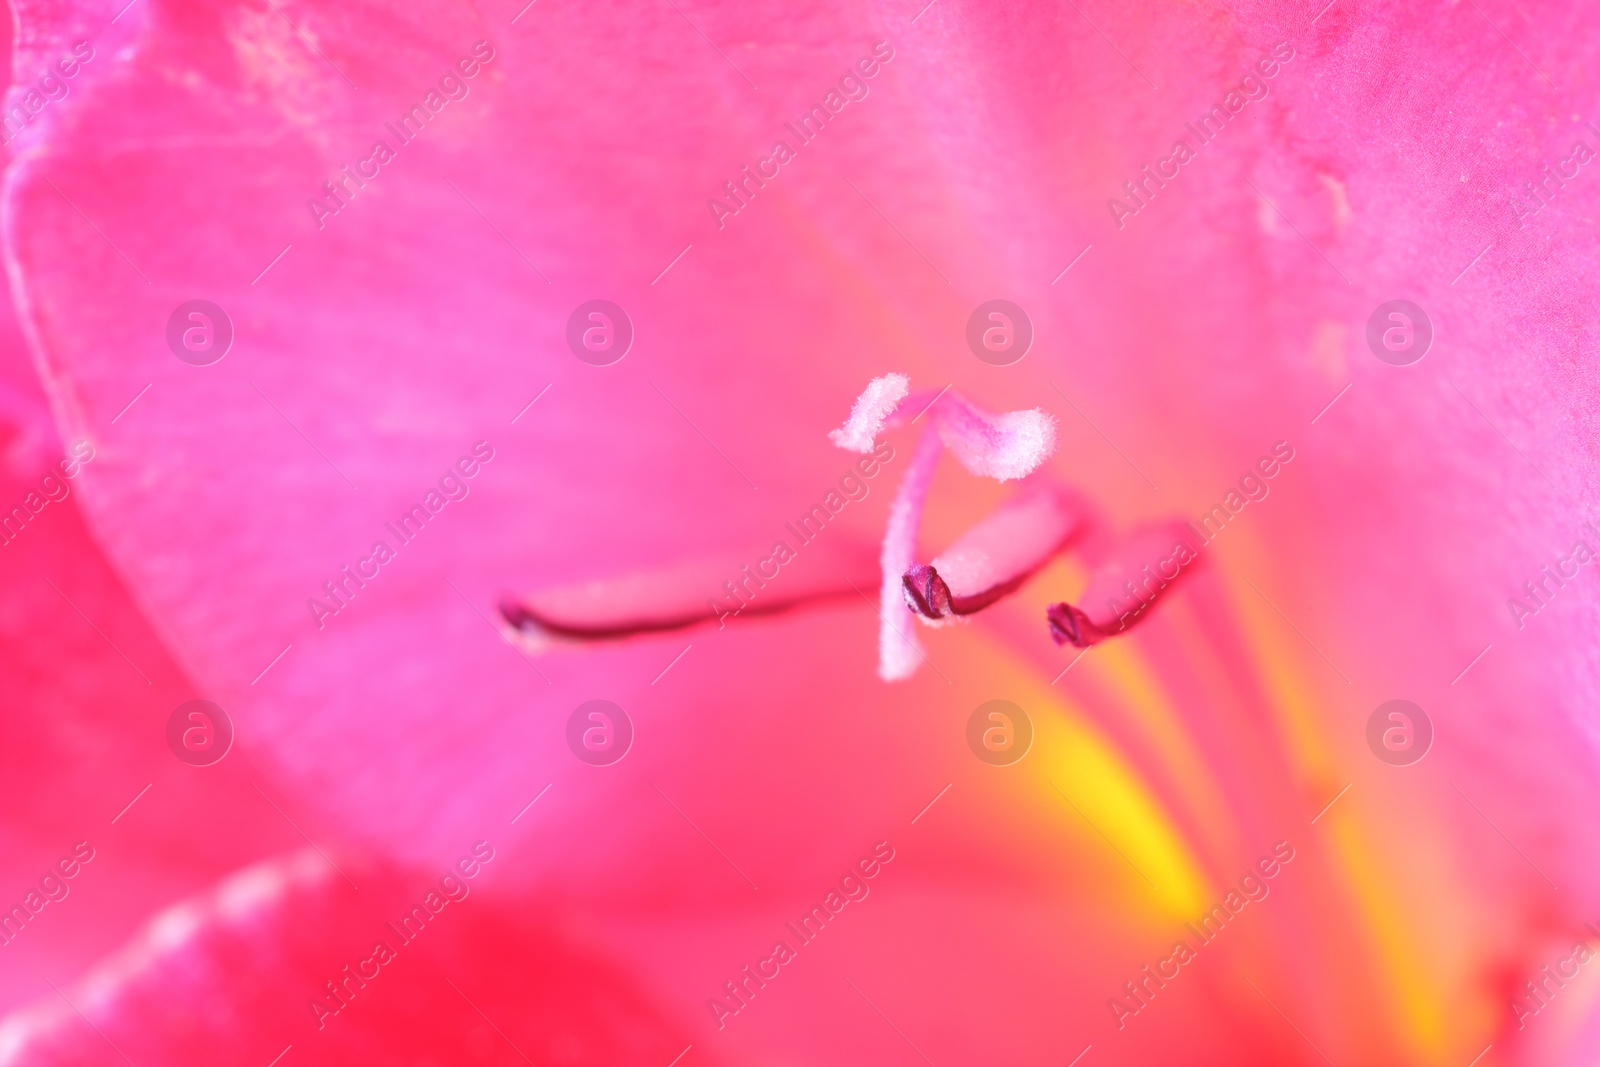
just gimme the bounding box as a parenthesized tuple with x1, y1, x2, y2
(0, 846, 686, 1067)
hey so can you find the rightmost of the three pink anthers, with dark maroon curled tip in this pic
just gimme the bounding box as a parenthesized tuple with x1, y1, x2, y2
(1046, 522, 1202, 648)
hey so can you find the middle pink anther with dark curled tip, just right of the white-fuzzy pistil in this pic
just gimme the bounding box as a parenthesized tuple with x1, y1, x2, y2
(902, 486, 1083, 619)
